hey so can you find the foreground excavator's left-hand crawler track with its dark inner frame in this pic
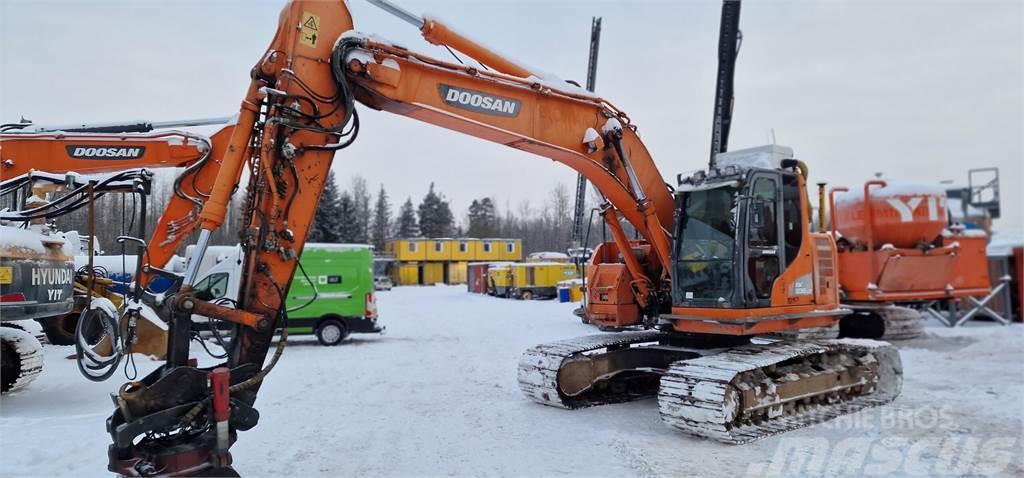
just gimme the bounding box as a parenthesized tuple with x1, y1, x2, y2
(518, 331, 671, 408)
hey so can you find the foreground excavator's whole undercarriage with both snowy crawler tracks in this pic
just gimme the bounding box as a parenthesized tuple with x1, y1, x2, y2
(518, 331, 903, 443)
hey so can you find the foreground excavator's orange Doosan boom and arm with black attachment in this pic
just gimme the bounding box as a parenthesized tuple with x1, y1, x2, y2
(108, 0, 674, 476)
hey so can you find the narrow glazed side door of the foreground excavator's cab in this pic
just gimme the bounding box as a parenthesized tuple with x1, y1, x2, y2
(744, 172, 783, 307)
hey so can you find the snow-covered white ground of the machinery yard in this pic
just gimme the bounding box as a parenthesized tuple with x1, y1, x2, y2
(0, 287, 1024, 477)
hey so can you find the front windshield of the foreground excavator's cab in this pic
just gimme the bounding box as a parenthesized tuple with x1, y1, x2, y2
(673, 184, 739, 306)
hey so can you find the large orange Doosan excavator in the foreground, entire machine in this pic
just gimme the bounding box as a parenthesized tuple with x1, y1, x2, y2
(12, 0, 902, 476)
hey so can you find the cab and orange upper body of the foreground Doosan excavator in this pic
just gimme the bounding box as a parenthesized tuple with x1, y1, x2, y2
(662, 145, 845, 336)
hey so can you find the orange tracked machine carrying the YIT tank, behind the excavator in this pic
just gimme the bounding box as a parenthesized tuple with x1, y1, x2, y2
(819, 179, 991, 340)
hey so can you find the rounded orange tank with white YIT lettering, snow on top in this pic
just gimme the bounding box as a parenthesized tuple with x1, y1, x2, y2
(831, 179, 947, 249)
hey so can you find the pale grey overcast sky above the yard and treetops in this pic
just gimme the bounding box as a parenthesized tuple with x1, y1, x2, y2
(0, 0, 1024, 227)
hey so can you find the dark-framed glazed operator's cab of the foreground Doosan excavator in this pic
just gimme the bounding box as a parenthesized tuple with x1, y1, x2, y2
(672, 164, 803, 308)
